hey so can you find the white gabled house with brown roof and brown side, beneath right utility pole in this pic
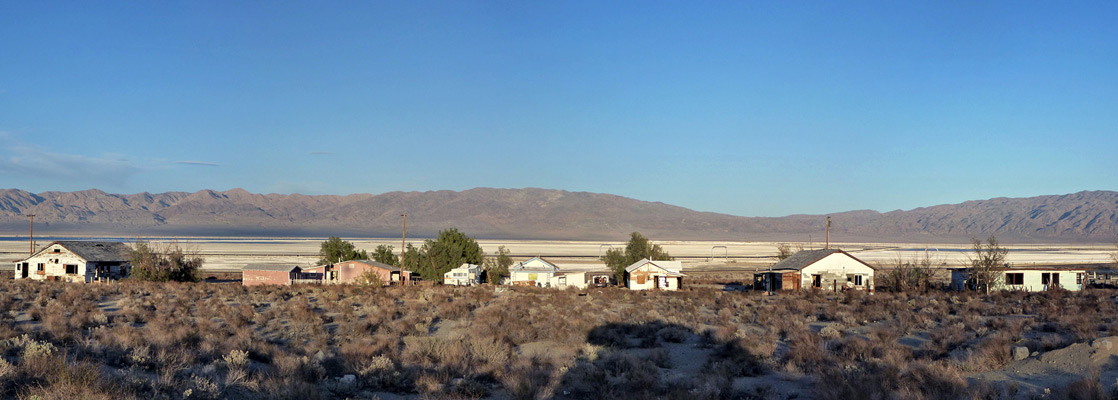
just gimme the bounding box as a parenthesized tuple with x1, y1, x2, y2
(754, 249, 875, 292)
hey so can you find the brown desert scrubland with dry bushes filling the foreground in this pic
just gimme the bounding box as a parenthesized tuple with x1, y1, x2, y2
(0, 280, 1118, 399)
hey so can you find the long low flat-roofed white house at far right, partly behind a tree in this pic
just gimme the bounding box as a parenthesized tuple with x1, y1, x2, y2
(951, 266, 1087, 292)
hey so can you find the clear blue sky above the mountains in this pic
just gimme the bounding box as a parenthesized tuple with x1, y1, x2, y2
(0, 1, 1118, 216)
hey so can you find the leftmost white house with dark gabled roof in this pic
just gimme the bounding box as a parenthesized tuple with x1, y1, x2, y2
(13, 240, 132, 283)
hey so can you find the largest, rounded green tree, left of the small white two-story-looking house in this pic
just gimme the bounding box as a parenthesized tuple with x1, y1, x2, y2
(418, 228, 484, 282)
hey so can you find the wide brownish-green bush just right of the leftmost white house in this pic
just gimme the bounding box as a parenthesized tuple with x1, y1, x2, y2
(131, 241, 203, 282)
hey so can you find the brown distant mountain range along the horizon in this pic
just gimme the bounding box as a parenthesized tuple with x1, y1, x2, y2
(0, 188, 1118, 242)
